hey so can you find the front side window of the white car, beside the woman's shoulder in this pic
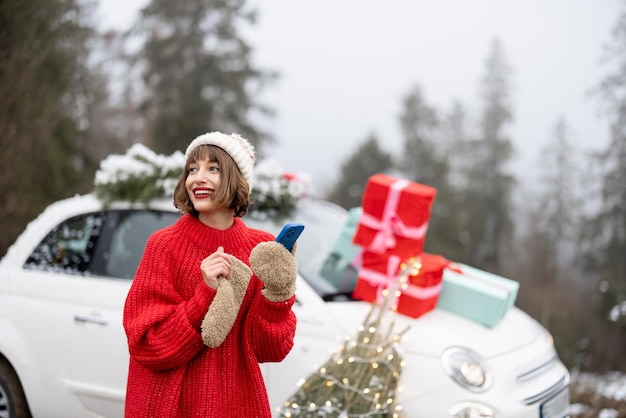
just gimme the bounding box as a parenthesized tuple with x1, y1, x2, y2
(98, 210, 180, 279)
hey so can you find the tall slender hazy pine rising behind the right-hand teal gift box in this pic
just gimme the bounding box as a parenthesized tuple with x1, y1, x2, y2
(463, 40, 515, 276)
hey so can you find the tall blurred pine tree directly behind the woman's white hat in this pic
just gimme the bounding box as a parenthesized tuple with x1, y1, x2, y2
(128, 0, 275, 154)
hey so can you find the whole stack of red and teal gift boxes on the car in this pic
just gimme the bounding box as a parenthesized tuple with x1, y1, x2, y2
(322, 174, 519, 327)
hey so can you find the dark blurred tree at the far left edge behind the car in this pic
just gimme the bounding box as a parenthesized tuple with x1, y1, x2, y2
(0, 0, 95, 255)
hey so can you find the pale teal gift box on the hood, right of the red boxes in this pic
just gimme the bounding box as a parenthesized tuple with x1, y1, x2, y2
(437, 263, 519, 328)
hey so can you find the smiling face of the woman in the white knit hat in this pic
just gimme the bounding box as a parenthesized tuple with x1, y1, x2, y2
(185, 160, 220, 213)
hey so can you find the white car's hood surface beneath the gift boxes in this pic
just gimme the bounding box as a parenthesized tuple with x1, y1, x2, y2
(327, 302, 546, 359)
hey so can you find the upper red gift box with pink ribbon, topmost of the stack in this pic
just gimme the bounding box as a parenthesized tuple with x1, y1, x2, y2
(353, 174, 437, 259)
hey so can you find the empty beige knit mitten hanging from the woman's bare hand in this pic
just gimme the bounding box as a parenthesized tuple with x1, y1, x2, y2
(201, 256, 252, 348)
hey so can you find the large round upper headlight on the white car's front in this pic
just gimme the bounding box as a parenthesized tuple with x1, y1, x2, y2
(441, 347, 492, 392)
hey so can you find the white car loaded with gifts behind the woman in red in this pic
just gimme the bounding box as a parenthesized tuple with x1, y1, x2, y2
(0, 195, 570, 418)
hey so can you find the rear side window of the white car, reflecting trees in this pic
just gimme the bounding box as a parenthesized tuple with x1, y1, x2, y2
(24, 213, 103, 274)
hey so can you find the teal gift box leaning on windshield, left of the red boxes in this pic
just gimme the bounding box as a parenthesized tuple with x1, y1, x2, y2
(320, 206, 363, 292)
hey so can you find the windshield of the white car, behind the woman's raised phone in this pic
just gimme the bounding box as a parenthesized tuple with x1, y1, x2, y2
(244, 199, 356, 301)
